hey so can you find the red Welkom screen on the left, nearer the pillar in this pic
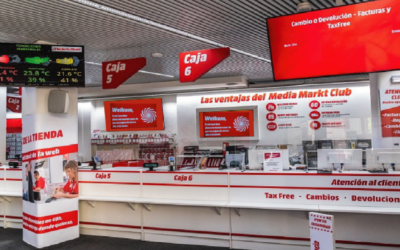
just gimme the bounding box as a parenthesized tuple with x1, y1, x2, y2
(104, 98, 164, 131)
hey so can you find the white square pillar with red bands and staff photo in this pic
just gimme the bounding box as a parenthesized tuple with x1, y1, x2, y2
(22, 88, 79, 248)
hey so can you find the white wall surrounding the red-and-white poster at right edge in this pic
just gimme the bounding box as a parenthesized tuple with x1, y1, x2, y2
(370, 71, 400, 148)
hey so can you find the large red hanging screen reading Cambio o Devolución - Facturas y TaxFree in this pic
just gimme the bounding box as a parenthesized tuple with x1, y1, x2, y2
(267, 0, 400, 81)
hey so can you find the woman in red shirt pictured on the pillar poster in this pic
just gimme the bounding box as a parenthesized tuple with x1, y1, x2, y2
(52, 161, 79, 198)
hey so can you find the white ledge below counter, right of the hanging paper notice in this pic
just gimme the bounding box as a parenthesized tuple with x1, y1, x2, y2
(319, 206, 400, 214)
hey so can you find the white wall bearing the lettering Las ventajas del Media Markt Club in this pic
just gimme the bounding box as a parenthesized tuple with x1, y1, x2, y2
(177, 83, 372, 149)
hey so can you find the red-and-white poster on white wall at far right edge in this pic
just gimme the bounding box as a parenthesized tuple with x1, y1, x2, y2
(380, 89, 400, 137)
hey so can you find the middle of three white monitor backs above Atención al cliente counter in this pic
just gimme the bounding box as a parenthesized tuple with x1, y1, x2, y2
(317, 149, 363, 171)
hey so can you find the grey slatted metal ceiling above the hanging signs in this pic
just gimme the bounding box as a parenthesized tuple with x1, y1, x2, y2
(0, 0, 371, 87)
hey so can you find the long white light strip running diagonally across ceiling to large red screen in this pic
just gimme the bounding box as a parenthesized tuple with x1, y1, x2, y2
(71, 0, 271, 63)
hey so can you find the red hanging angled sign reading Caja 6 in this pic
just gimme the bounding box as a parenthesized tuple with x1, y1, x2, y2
(179, 48, 230, 82)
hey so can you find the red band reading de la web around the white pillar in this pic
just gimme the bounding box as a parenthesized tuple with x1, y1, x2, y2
(22, 144, 78, 162)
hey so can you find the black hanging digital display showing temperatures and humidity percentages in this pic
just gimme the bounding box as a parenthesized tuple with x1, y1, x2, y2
(0, 43, 85, 87)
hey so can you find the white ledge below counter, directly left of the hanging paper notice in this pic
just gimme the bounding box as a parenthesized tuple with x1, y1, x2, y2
(226, 202, 319, 211)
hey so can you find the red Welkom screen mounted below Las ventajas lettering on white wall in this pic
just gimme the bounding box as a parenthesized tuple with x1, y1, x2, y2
(197, 106, 259, 141)
